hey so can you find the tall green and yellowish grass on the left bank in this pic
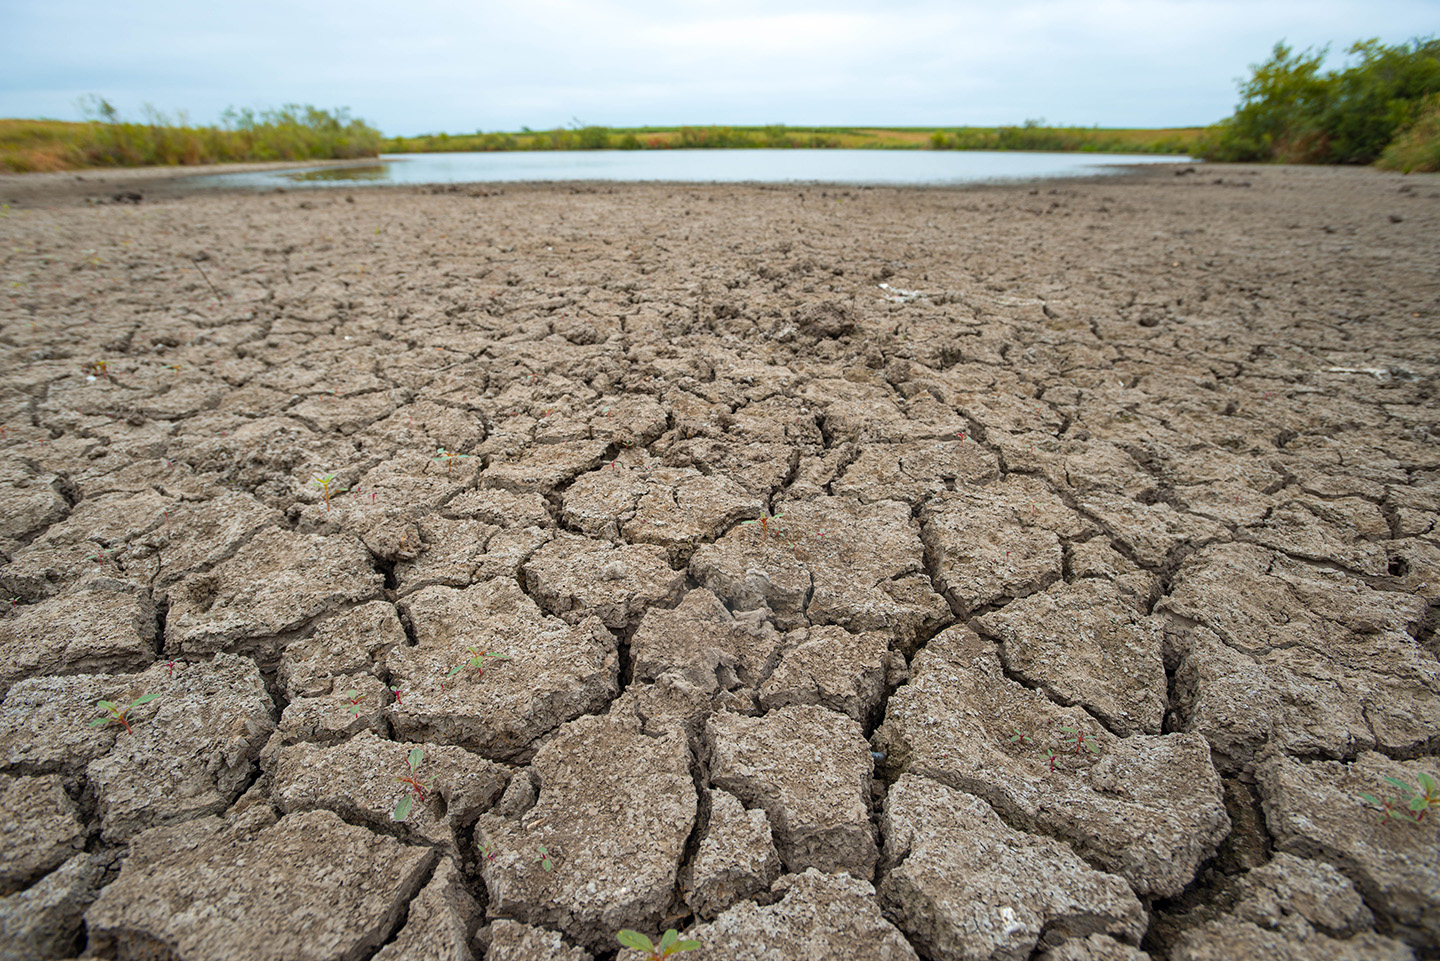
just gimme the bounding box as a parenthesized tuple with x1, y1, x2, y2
(0, 98, 383, 173)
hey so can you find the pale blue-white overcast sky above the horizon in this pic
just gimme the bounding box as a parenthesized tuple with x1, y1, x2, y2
(0, 0, 1440, 134)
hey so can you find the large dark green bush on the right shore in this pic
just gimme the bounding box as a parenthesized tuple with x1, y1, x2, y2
(1197, 37, 1440, 164)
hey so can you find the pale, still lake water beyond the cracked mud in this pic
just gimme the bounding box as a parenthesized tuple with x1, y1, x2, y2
(182, 150, 1189, 190)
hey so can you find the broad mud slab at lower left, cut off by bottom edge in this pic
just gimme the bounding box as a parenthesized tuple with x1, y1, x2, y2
(85, 811, 436, 961)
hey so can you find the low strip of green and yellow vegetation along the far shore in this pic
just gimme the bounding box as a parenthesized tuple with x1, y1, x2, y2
(384, 121, 1200, 154)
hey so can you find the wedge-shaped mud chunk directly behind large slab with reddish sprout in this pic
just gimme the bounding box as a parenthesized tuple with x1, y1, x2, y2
(975, 581, 1166, 738)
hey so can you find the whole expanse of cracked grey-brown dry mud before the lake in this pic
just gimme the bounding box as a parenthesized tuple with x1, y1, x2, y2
(0, 166, 1440, 961)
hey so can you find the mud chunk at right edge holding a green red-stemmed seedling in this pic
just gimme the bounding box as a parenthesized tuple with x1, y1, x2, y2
(1256, 754, 1440, 951)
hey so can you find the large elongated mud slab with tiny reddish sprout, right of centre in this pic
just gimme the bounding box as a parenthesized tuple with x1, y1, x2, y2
(876, 627, 1230, 898)
